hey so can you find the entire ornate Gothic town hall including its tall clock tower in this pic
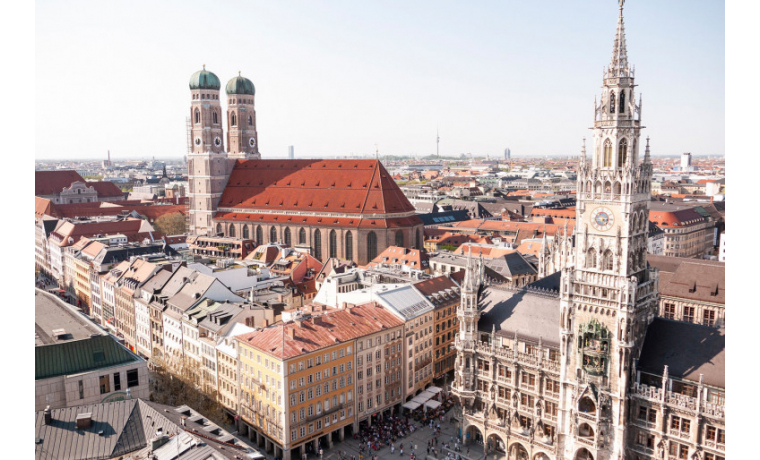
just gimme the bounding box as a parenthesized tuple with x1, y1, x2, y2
(453, 1, 725, 460)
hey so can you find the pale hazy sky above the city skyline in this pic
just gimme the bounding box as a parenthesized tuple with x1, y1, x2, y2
(35, 0, 725, 159)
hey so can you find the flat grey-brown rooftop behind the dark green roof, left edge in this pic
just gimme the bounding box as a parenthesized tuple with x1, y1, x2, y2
(34, 290, 107, 346)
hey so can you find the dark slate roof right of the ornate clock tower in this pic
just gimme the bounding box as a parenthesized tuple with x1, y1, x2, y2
(638, 318, 726, 388)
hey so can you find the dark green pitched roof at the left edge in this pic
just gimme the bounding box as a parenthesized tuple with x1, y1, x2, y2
(34, 335, 141, 380)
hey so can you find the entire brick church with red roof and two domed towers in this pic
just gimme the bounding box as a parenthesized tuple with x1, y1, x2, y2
(188, 67, 423, 265)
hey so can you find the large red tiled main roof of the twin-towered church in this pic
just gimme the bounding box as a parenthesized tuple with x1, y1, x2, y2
(216, 160, 414, 216)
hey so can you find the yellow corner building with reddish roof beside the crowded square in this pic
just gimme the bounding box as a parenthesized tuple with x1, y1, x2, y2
(235, 305, 401, 460)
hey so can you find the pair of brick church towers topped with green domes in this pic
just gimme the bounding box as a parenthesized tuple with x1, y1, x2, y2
(188, 65, 261, 235)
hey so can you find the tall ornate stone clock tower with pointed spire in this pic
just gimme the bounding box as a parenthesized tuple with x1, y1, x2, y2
(559, 0, 658, 460)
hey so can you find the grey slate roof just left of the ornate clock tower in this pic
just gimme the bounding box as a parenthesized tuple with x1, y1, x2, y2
(478, 287, 560, 347)
